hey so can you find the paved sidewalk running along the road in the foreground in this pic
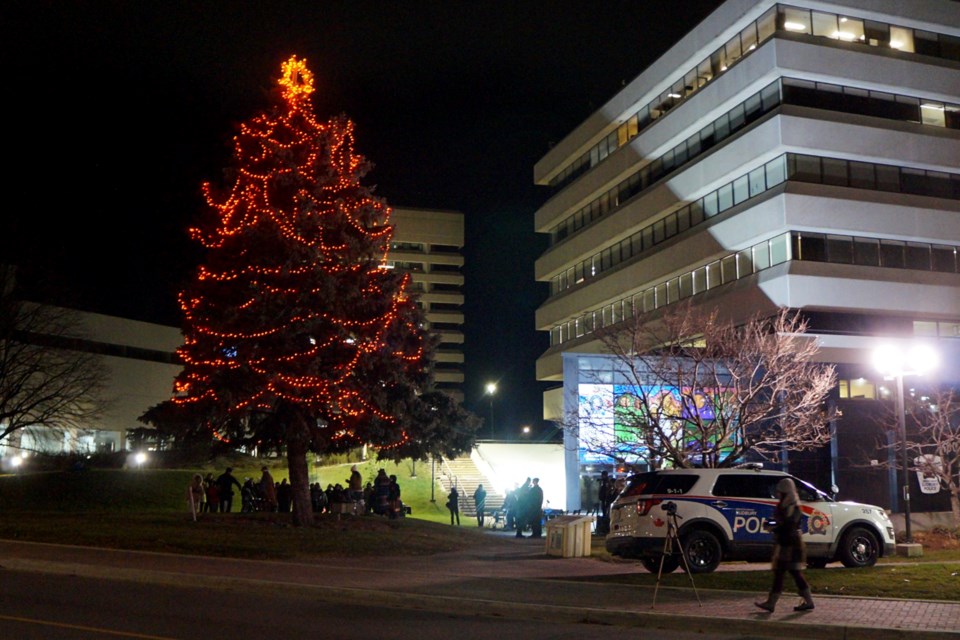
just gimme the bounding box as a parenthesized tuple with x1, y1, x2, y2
(0, 535, 960, 640)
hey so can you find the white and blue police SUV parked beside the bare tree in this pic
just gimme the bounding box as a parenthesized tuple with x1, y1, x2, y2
(606, 464, 895, 573)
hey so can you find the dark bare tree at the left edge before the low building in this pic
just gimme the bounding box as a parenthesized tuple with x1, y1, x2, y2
(0, 268, 106, 446)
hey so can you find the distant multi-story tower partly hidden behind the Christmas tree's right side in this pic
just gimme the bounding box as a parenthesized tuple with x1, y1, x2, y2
(389, 208, 464, 402)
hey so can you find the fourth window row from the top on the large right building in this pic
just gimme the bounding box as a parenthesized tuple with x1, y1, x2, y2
(550, 232, 957, 346)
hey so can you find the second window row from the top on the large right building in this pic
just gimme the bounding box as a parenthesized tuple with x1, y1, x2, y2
(550, 78, 960, 245)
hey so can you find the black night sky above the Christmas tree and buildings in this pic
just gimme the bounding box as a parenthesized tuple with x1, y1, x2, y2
(0, 0, 720, 437)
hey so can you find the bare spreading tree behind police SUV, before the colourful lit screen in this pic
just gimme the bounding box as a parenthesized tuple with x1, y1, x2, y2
(567, 304, 836, 468)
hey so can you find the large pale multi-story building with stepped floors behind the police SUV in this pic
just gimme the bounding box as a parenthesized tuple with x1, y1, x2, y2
(534, 0, 960, 508)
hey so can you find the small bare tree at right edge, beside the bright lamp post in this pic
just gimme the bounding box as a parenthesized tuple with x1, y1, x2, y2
(875, 389, 960, 526)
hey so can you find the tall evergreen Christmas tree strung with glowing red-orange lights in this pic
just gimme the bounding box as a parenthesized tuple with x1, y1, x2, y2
(160, 57, 484, 524)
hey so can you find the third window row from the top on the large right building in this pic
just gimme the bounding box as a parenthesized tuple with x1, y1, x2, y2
(550, 153, 960, 296)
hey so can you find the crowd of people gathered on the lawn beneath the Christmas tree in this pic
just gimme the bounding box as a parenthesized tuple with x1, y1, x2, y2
(187, 465, 406, 520)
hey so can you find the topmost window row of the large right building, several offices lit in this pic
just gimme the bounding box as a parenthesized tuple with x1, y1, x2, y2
(550, 5, 960, 187)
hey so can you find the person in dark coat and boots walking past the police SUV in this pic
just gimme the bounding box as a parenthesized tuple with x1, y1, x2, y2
(754, 478, 813, 613)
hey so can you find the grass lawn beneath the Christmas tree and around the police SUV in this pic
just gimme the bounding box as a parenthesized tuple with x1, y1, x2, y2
(0, 461, 960, 601)
